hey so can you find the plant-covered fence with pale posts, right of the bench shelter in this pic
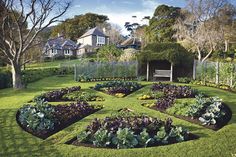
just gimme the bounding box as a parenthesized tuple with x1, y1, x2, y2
(193, 60, 236, 87)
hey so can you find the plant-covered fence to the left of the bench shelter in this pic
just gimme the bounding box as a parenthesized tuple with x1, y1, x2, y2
(61, 61, 138, 81)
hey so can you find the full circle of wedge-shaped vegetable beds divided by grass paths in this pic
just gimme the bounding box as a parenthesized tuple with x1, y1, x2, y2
(16, 81, 232, 149)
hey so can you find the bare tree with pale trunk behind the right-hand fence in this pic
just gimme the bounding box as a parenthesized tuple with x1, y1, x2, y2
(174, 0, 228, 61)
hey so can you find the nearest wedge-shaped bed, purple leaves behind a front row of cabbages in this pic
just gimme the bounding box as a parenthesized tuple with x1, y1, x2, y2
(67, 108, 198, 149)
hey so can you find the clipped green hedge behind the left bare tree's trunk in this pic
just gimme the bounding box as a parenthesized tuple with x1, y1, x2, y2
(0, 68, 74, 89)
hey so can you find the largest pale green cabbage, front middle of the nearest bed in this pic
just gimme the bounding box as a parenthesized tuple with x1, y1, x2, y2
(112, 128, 138, 149)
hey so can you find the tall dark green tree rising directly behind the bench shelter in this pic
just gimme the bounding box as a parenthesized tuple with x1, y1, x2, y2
(146, 5, 181, 42)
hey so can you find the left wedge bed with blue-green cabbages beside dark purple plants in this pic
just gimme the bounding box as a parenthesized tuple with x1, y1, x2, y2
(16, 100, 102, 139)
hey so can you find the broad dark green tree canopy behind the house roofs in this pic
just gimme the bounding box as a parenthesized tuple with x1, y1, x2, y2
(51, 13, 108, 41)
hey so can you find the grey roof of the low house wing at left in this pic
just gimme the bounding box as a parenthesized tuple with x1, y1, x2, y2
(46, 36, 77, 49)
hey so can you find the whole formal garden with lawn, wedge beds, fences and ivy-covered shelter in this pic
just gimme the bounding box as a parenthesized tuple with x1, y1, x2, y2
(0, 44, 236, 156)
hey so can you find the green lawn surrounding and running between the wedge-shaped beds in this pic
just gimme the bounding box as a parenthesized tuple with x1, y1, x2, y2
(0, 76, 236, 157)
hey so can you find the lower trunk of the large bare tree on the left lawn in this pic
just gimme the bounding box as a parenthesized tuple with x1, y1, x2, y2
(12, 63, 24, 89)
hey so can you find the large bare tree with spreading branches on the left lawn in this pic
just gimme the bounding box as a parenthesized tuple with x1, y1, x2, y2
(0, 0, 71, 89)
